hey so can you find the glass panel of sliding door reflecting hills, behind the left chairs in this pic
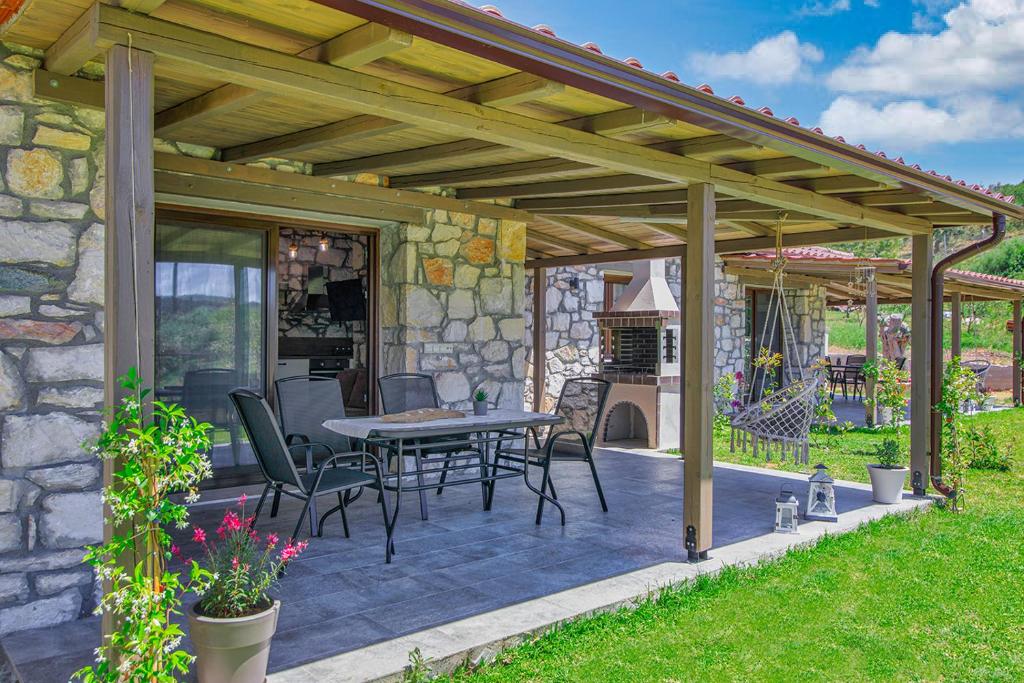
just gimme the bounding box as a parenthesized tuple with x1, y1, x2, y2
(154, 221, 268, 484)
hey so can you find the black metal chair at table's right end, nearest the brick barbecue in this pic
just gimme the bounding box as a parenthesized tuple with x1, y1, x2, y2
(488, 377, 611, 524)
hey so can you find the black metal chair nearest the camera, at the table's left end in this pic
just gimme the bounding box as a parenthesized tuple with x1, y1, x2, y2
(228, 389, 391, 548)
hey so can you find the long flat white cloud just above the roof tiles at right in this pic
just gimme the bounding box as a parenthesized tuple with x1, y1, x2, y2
(819, 95, 1024, 151)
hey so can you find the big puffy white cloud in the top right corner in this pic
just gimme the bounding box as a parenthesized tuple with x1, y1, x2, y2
(828, 0, 1024, 97)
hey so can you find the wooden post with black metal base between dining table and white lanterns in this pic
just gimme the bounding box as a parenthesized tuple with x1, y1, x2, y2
(680, 182, 715, 561)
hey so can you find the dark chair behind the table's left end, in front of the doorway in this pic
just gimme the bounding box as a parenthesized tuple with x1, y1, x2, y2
(270, 376, 360, 517)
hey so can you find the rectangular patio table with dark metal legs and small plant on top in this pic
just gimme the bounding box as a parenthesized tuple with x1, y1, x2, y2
(324, 409, 565, 562)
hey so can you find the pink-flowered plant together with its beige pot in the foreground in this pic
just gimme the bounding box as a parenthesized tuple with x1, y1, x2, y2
(187, 496, 306, 683)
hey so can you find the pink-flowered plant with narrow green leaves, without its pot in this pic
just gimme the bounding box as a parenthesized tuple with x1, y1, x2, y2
(190, 495, 307, 618)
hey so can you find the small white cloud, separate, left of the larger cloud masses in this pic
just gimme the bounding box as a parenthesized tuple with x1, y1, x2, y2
(690, 31, 824, 85)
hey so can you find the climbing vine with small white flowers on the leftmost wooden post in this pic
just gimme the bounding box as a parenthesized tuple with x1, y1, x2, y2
(75, 369, 211, 683)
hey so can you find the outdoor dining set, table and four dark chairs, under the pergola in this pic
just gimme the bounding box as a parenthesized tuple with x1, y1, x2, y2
(229, 373, 609, 562)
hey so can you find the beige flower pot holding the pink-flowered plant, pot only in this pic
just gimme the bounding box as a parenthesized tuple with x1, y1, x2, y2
(188, 600, 281, 683)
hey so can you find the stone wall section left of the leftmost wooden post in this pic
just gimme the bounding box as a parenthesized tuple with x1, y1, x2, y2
(0, 45, 103, 635)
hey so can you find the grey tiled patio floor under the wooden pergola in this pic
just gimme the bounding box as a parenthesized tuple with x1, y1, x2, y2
(5, 450, 892, 683)
